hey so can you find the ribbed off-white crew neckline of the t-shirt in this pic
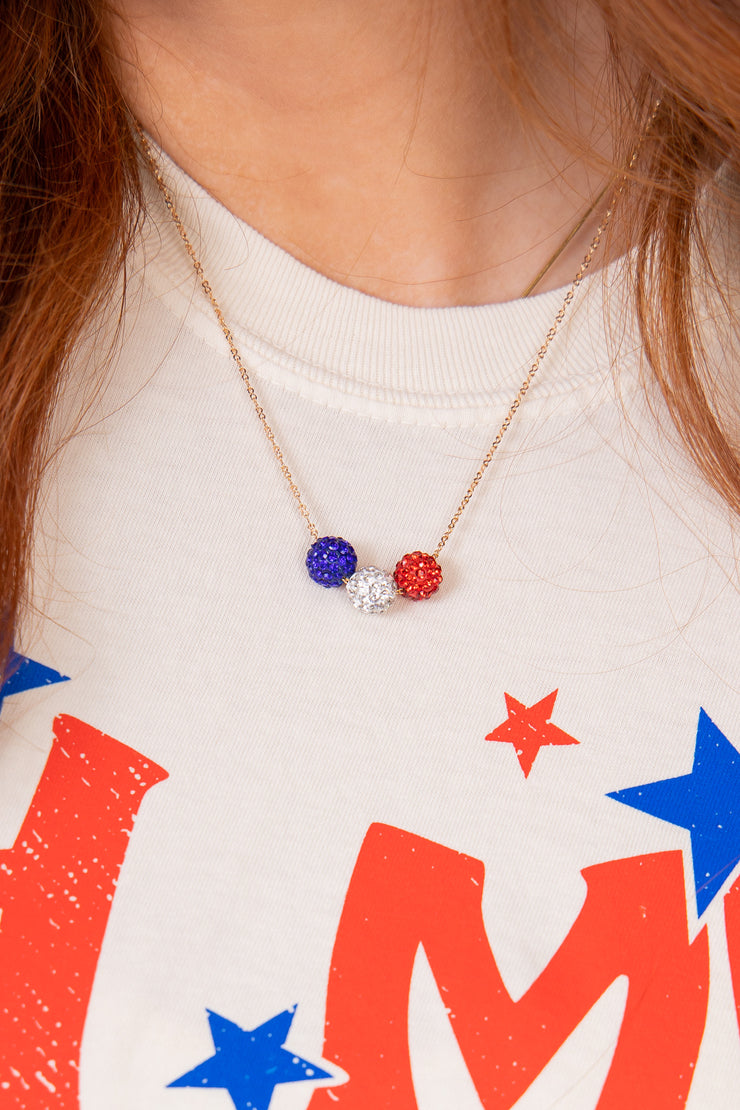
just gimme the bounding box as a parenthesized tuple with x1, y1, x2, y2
(137, 138, 626, 418)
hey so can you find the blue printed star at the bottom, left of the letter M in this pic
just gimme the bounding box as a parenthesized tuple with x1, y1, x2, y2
(168, 1006, 332, 1110)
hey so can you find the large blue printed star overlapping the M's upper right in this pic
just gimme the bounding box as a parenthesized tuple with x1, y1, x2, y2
(608, 709, 740, 916)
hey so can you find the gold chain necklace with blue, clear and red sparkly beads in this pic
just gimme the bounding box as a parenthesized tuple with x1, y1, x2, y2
(134, 107, 660, 613)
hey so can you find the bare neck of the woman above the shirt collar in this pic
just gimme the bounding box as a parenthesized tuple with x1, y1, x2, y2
(114, 0, 609, 305)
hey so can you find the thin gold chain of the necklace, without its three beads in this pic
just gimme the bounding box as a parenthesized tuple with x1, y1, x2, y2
(134, 99, 660, 559)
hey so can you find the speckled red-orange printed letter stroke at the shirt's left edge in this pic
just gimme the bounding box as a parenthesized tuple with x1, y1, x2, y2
(0, 716, 168, 1110)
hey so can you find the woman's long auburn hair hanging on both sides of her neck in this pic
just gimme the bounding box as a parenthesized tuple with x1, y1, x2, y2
(0, 0, 740, 679)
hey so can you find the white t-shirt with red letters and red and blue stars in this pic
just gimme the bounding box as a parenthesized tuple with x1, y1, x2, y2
(0, 149, 740, 1110)
